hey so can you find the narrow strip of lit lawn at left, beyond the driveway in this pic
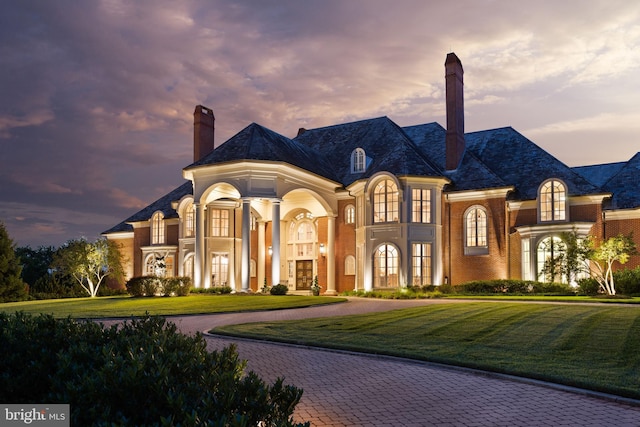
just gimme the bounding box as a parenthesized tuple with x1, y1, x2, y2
(0, 294, 345, 318)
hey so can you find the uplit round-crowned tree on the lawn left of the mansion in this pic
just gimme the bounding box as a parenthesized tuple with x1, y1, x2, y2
(52, 238, 123, 297)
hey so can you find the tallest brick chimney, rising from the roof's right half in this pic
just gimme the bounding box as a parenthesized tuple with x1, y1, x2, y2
(444, 52, 465, 170)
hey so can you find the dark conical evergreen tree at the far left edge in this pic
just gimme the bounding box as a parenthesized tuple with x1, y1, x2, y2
(0, 222, 27, 302)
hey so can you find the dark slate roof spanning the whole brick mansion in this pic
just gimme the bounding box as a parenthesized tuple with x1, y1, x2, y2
(105, 117, 640, 234)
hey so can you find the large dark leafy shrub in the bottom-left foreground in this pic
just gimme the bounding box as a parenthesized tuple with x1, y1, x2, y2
(0, 313, 308, 426)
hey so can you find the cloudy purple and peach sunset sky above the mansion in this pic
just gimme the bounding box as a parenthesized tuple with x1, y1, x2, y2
(0, 0, 640, 248)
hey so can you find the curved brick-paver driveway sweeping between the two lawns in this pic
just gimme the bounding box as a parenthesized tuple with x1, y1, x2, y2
(171, 298, 640, 427)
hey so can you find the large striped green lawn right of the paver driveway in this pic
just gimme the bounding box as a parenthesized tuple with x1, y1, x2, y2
(213, 302, 640, 399)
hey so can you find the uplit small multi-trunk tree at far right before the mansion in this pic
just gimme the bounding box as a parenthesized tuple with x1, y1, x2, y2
(585, 234, 637, 295)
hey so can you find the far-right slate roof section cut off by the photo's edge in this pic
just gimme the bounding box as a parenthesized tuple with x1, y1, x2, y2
(602, 153, 640, 209)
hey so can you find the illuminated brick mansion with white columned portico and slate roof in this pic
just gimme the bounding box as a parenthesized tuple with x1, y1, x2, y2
(103, 53, 640, 295)
